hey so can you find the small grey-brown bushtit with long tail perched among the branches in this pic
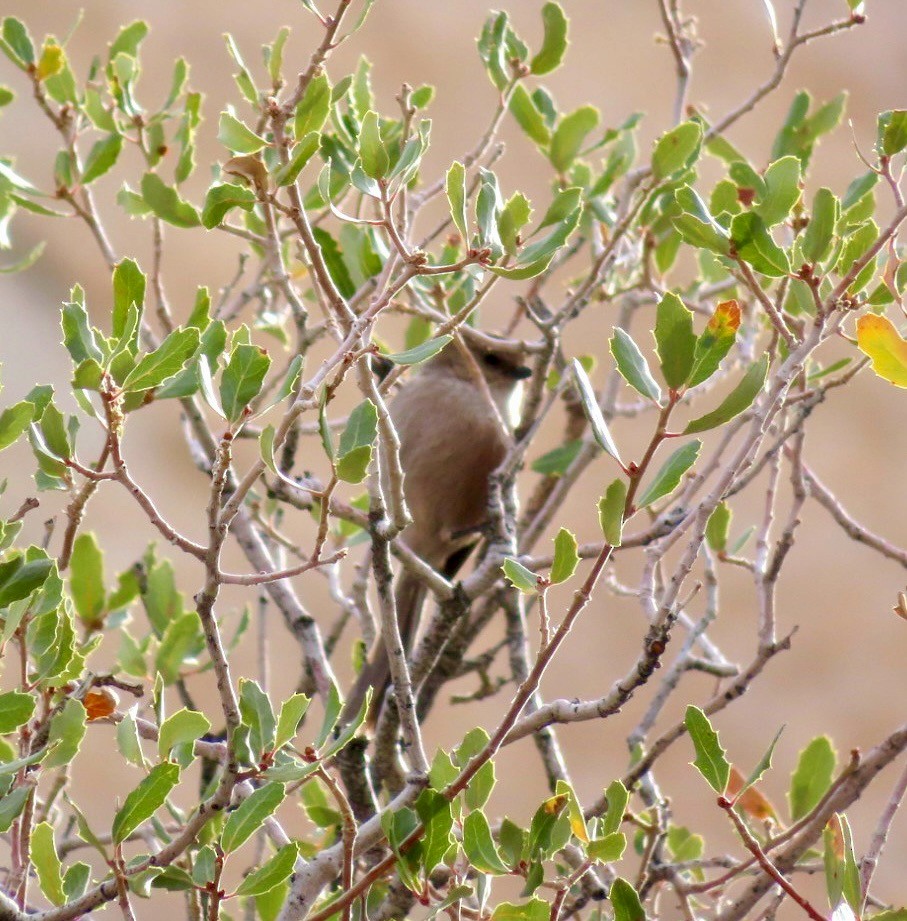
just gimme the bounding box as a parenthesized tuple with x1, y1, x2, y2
(344, 342, 532, 719)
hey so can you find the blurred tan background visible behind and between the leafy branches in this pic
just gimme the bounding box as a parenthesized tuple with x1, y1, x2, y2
(0, 0, 907, 917)
